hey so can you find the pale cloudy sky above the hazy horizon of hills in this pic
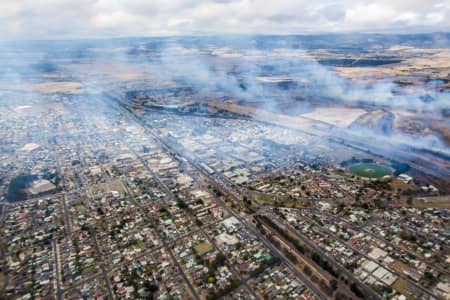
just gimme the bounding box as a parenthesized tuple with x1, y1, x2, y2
(0, 0, 450, 39)
